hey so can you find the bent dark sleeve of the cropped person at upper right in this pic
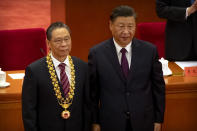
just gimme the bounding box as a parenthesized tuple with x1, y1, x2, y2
(156, 0, 187, 22)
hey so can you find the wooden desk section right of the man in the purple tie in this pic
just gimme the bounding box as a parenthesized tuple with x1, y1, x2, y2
(162, 62, 197, 131)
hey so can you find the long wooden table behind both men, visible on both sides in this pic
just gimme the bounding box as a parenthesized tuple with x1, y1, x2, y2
(0, 62, 197, 131)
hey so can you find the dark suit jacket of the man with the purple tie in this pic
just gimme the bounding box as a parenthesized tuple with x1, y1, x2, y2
(88, 39, 165, 131)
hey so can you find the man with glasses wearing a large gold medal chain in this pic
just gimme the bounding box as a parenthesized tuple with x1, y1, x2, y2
(22, 22, 90, 131)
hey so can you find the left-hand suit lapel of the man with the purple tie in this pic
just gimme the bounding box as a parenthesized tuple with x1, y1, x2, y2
(106, 39, 126, 81)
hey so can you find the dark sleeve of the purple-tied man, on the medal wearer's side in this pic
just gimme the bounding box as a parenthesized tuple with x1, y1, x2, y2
(88, 49, 99, 124)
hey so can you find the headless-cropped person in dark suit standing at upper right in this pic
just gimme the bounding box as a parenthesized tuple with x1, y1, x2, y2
(156, 0, 197, 61)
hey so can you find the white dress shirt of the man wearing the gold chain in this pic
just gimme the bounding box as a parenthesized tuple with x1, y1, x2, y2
(51, 53, 71, 83)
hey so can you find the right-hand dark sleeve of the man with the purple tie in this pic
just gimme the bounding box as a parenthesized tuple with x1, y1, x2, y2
(151, 48, 165, 123)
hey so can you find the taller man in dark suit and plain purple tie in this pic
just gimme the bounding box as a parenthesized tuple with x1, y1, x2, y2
(88, 6, 165, 131)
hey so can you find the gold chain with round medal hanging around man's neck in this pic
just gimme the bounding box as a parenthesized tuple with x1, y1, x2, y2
(46, 53, 75, 119)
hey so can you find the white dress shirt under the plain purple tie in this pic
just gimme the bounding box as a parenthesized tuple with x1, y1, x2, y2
(113, 38, 132, 69)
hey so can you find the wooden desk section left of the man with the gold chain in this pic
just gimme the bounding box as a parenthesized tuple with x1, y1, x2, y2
(0, 70, 24, 131)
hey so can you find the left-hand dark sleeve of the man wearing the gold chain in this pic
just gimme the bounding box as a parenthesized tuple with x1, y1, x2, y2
(22, 67, 38, 131)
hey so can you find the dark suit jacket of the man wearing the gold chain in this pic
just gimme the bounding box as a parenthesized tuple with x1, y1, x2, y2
(22, 57, 90, 131)
